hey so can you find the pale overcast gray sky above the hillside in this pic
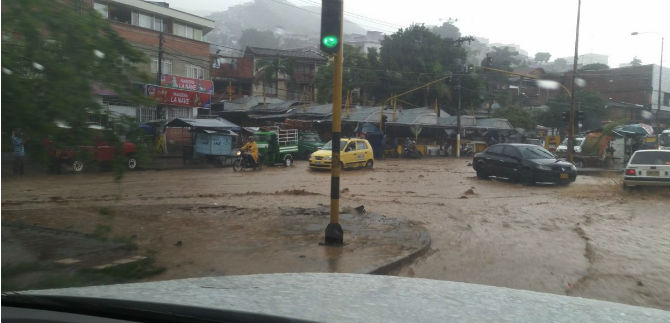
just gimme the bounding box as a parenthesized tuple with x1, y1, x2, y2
(167, 0, 670, 67)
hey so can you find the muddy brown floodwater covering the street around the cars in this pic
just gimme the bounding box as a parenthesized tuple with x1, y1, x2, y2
(2, 158, 670, 309)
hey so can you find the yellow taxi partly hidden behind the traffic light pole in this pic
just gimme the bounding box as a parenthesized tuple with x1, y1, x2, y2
(309, 138, 375, 169)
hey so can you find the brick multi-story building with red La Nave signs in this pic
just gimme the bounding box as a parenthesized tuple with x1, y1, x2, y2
(89, 0, 214, 122)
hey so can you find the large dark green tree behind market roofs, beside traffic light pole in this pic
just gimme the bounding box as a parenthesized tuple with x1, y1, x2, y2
(316, 25, 481, 111)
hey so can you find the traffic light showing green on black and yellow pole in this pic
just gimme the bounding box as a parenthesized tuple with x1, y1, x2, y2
(320, 0, 342, 54)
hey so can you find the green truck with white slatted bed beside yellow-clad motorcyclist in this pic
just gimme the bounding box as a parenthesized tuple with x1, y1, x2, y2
(254, 129, 299, 167)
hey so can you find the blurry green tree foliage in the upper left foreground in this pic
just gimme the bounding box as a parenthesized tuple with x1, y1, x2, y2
(2, 0, 150, 166)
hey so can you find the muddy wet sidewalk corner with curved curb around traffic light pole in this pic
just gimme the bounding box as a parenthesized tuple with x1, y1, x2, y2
(2, 204, 430, 289)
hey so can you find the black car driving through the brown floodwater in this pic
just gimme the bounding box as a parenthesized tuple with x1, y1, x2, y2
(472, 144, 577, 185)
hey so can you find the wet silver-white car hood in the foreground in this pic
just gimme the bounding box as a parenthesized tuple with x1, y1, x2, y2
(13, 273, 670, 322)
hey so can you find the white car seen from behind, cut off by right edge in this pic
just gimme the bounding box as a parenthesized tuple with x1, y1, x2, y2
(623, 149, 670, 188)
